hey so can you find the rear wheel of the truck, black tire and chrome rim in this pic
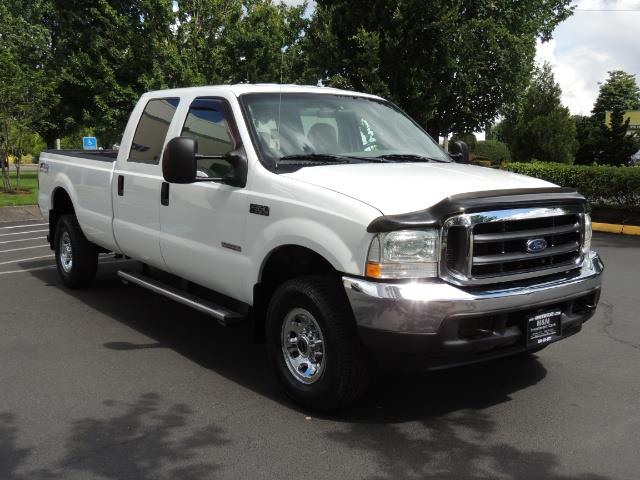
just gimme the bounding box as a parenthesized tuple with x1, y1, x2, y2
(54, 215, 98, 289)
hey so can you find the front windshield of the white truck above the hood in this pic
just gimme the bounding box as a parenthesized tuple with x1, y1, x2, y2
(242, 93, 450, 168)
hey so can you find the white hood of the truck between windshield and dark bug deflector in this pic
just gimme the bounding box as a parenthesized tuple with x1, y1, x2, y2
(284, 163, 555, 215)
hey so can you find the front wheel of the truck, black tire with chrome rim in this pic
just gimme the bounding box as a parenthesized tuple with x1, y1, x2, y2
(267, 276, 373, 411)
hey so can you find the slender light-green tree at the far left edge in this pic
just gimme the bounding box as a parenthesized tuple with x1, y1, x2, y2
(0, 2, 55, 191)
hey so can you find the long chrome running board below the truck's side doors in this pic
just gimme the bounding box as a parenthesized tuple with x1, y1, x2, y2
(118, 270, 246, 326)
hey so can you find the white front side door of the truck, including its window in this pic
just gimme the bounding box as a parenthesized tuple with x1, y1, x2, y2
(160, 97, 249, 298)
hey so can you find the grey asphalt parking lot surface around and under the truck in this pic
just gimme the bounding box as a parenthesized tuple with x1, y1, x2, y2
(0, 220, 640, 480)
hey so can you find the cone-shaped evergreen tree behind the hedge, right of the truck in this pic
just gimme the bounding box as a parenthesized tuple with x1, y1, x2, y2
(503, 64, 578, 163)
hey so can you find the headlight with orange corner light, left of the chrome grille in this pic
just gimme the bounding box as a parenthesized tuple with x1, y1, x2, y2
(366, 230, 440, 278)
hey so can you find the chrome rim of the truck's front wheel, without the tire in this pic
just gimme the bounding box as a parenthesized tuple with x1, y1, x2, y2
(282, 308, 326, 384)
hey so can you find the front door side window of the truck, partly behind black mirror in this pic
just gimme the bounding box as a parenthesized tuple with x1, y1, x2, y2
(180, 98, 237, 178)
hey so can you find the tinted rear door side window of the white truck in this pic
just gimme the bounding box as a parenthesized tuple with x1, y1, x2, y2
(129, 98, 180, 165)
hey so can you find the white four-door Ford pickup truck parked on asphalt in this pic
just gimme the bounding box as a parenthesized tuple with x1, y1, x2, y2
(39, 85, 603, 410)
